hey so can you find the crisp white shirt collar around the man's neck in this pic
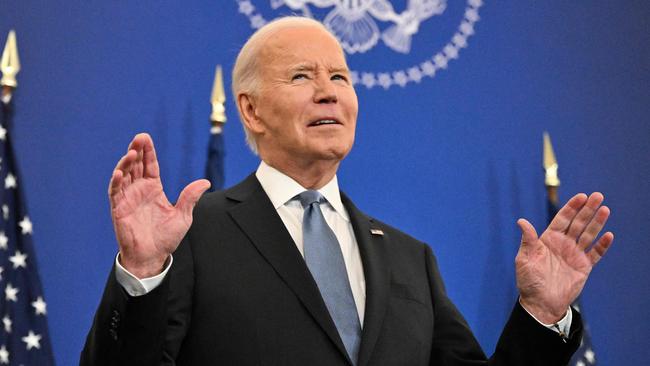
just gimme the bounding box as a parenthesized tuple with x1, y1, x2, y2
(255, 161, 350, 221)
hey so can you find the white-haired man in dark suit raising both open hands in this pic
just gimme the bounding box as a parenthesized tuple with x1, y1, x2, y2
(81, 17, 613, 366)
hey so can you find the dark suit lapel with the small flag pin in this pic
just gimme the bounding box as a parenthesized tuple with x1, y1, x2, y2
(341, 193, 390, 366)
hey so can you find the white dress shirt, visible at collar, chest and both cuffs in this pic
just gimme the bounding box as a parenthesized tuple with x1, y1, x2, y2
(115, 161, 573, 335)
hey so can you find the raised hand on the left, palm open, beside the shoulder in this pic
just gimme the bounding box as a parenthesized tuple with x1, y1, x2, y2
(108, 133, 210, 278)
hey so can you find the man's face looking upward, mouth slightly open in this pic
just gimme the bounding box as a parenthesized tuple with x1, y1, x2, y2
(249, 27, 358, 165)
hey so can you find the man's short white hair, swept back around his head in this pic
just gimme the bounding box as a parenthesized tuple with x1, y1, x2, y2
(232, 16, 338, 155)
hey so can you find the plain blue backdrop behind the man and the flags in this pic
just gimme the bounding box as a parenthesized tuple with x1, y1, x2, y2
(0, 0, 650, 365)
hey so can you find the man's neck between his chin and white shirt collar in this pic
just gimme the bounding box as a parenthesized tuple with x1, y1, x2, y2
(262, 158, 340, 190)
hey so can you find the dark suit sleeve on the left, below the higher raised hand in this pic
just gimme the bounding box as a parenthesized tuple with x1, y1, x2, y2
(79, 233, 193, 366)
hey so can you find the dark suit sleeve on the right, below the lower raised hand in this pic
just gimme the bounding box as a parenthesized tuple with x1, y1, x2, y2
(425, 246, 582, 366)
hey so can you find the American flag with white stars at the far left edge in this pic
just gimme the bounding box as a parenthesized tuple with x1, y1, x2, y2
(0, 95, 54, 366)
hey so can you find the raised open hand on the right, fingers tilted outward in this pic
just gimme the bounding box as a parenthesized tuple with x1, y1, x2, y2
(515, 192, 614, 324)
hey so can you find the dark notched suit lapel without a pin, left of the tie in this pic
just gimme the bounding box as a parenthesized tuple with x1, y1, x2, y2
(226, 175, 349, 360)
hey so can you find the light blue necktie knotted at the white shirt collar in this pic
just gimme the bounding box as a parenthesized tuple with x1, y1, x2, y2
(298, 191, 361, 365)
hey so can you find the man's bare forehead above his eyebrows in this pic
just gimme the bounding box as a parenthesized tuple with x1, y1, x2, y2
(260, 27, 347, 70)
